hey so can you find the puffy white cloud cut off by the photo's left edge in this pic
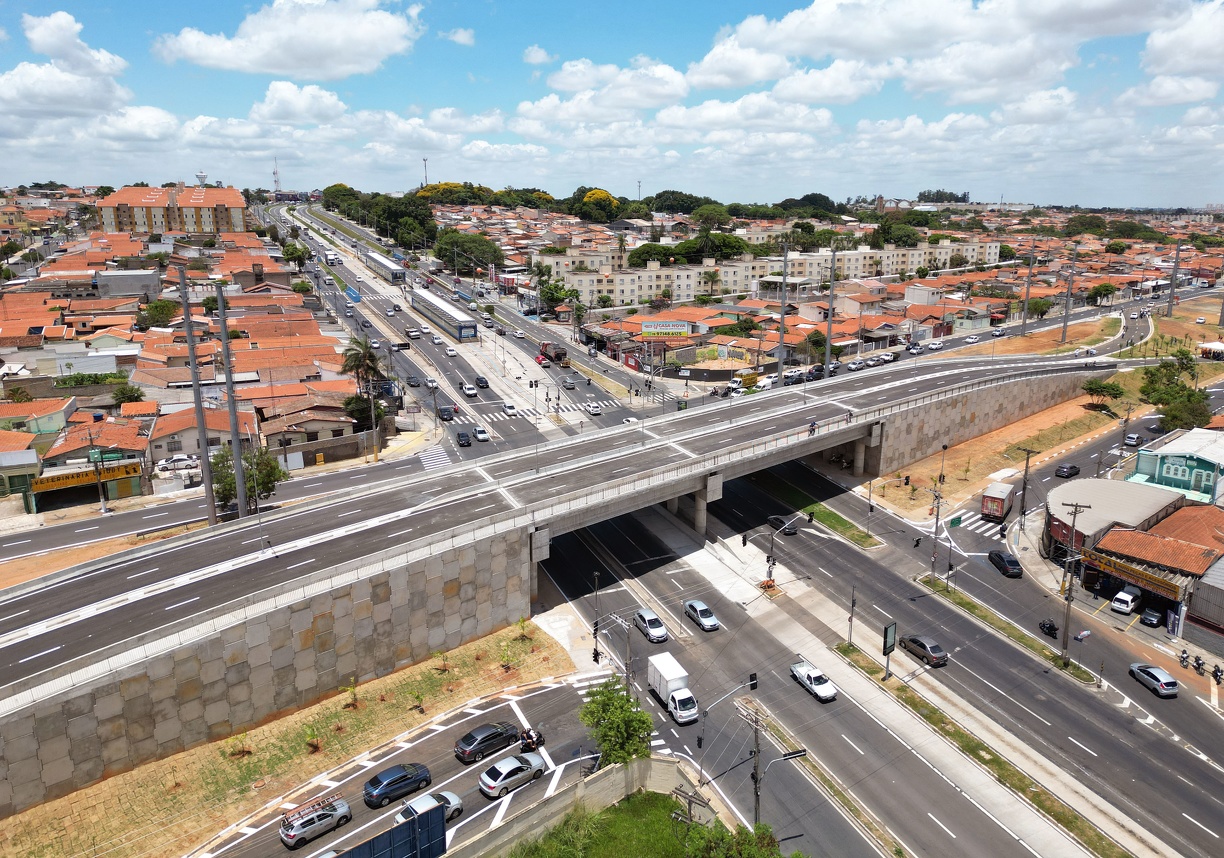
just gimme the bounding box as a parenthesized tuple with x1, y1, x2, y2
(0, 12, 132, 118)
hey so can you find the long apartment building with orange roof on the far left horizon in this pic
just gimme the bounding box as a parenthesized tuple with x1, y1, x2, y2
(98, 182, 246, 235)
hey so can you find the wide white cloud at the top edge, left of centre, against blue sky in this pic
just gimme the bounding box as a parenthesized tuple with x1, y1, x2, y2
(153, 0, 425, 80)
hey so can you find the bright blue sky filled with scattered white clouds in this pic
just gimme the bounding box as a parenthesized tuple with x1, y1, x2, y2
(0, 0, 1224, 207)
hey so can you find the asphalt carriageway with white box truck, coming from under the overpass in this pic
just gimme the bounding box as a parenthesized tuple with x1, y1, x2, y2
(546, 517, 1047, 856)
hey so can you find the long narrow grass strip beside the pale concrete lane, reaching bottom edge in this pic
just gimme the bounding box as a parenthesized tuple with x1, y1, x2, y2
(836, 644, 1131, 858)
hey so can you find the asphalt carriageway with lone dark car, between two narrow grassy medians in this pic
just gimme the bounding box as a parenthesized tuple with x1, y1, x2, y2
(710, 465, 1224, 854)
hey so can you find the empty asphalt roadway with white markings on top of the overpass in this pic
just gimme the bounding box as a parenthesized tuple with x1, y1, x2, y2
(0, 362, 1101, 684)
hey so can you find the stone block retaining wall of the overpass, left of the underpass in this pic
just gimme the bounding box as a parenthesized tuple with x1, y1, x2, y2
(0, 521, 534, 816)
